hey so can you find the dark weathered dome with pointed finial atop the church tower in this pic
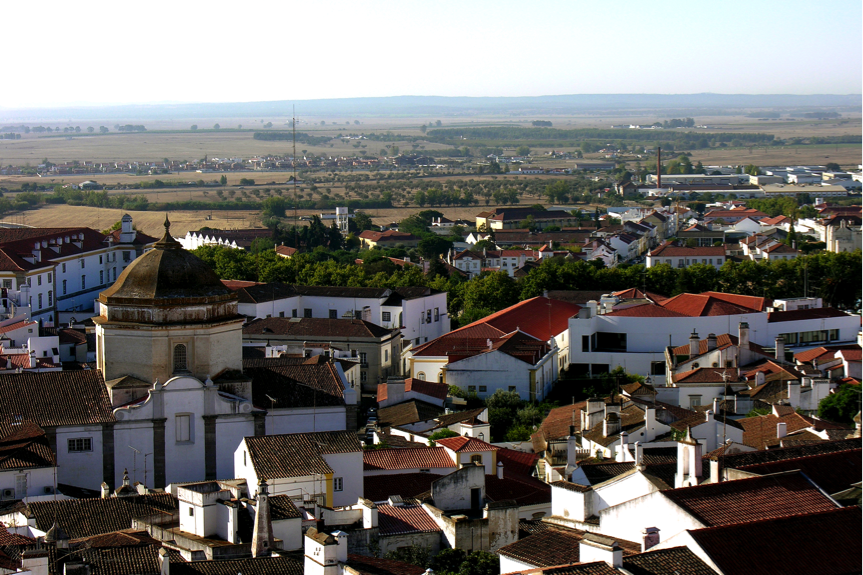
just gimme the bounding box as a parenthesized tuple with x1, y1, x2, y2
(99, 216, 236, 304)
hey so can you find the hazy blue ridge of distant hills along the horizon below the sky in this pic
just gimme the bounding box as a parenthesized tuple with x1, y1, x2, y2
(0, 94, 863, 122)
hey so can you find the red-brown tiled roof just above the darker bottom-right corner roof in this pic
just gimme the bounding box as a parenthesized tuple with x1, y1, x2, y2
(662, 472, 836, 527)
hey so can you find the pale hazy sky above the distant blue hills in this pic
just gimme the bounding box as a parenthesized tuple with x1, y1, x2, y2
(0, 0, 863, 108)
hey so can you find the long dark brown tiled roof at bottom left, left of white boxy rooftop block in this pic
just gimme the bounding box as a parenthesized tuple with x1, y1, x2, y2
(25, 493, 179, 539)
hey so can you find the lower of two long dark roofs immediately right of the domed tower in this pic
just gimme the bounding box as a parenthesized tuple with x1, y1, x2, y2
(243, 317, 398, 339)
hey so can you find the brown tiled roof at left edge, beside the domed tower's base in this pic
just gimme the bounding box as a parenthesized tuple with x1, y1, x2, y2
(0, 369, 115, 427)
